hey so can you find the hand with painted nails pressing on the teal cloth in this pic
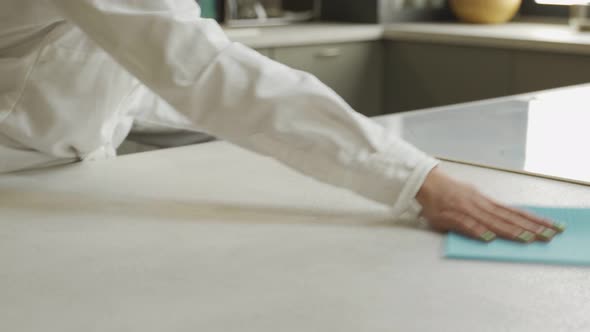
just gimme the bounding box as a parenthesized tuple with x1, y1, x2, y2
(416, 168, 565, 243)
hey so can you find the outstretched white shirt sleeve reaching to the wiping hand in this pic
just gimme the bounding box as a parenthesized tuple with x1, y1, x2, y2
(52, 0, 436, 214)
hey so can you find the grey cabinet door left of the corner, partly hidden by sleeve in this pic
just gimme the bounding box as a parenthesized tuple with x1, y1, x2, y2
(273, 42, 383, 116)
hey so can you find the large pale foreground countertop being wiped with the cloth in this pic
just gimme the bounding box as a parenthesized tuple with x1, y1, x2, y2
(0, 87, 590, 332)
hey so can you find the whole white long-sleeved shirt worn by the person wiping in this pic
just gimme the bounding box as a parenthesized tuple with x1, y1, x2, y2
(0, 0, 436, 217)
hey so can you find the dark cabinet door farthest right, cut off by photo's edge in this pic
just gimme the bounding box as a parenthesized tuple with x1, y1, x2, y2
(512, 51, 590, 93)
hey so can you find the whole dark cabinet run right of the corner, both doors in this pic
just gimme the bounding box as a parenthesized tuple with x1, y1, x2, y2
(384, 41, 590, 113)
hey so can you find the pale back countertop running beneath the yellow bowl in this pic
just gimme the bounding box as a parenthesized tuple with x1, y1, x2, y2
(226, 22, 590, 55)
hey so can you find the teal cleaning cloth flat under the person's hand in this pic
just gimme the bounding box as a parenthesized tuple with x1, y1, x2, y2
(445, 206, 590, 266)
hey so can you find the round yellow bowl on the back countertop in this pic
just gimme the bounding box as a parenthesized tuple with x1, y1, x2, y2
(449, 0, 522, 24)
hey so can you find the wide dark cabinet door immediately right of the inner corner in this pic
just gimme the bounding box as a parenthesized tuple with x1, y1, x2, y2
(384, 41, 511, 113)
